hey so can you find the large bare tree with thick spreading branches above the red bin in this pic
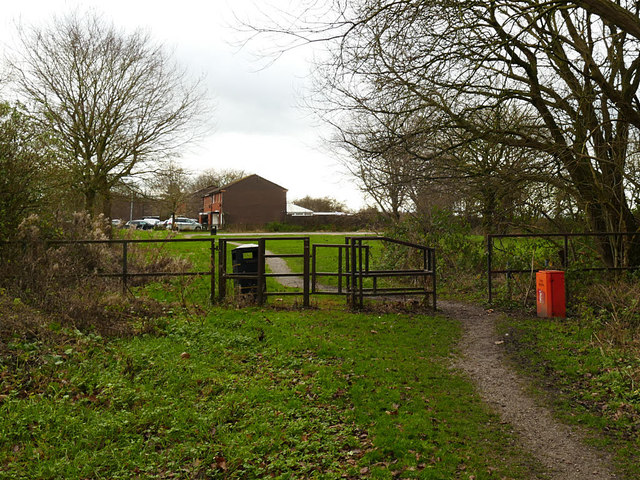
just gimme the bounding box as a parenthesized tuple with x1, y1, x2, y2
(250, 0, 640, 265)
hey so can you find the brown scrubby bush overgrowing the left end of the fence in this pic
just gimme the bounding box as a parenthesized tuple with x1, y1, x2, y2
(0, 213, 180, 344)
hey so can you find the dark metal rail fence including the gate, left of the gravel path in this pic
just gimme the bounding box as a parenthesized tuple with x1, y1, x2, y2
(0, 236, 436, 309)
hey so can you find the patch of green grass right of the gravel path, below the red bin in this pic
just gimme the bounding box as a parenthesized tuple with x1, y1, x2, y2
(500, 318, 640, 478)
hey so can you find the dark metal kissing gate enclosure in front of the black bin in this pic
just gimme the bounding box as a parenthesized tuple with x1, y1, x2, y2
(216, 236, 436, 309)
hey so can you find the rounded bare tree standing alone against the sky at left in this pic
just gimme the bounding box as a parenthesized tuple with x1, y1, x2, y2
(10, 13, 205, 218)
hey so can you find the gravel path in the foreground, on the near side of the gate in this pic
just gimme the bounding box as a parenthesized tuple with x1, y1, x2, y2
(438, 301, 619, 480)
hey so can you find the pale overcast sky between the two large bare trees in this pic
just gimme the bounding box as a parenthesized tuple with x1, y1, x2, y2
(0, 0, 364, 209)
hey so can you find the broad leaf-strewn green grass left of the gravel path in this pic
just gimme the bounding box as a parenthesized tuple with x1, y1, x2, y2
(0, 309, 536, 480)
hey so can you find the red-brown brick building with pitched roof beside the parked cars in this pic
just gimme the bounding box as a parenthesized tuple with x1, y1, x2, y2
(200, 175, 287, 226)
